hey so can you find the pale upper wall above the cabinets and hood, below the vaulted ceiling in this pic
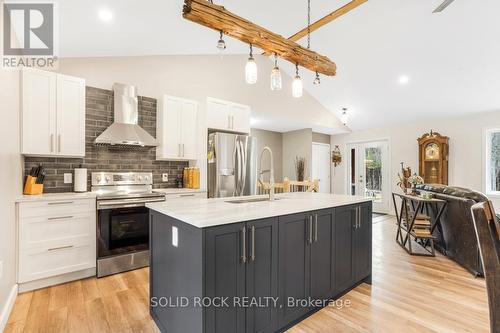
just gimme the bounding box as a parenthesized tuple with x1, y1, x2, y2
(59, 55, 342, 132)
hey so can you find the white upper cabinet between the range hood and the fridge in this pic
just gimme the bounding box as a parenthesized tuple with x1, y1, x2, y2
(156, 95, 198, 160)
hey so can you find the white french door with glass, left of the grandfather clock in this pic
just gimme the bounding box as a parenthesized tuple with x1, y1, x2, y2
(347, 140, 391, 213)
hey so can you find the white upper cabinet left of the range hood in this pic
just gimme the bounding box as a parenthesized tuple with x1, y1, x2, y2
(21, 69, 85, 157)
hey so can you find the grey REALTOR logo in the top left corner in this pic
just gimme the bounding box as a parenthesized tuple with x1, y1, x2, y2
(2, 2, 56, 68)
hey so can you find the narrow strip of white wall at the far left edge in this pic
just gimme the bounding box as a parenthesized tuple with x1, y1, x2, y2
(0, 69, 22, 324)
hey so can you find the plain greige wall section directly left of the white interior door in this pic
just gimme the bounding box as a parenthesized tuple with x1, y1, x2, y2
(283, 128, 312, 180)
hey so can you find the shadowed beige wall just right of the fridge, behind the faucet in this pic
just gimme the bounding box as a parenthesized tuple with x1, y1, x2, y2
(250, 128, 283, 182)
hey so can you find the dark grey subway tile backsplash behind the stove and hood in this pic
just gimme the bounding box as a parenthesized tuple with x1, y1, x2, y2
(24, 87, 188, 193)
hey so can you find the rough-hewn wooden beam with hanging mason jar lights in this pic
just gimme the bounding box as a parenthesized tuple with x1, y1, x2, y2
(182, 0, 338, 76)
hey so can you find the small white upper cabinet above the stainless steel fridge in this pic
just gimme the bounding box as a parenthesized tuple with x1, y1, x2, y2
(207, 97, 250, 134)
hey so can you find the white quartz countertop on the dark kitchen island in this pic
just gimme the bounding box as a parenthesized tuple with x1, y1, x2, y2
(146, 192, 371, 228)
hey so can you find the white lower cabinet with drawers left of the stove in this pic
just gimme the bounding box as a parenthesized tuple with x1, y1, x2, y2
(18, 199, 96, 283)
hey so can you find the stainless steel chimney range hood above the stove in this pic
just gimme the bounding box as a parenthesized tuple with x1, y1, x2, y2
(94, 83, 158, 148)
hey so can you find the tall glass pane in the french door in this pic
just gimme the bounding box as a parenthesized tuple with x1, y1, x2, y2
(364, 147, 383, 202)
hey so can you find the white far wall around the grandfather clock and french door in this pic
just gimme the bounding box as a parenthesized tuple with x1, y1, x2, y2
(331, 110, 500, 212)
